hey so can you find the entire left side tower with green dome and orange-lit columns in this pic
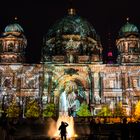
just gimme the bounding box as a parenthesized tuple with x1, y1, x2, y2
(0, 23, 27, 63)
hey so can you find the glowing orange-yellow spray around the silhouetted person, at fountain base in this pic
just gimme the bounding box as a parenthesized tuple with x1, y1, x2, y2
(47, 116, 78, 140)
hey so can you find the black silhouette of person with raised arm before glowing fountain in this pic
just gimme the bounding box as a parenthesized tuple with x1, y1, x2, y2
(59, 121, 68, 140)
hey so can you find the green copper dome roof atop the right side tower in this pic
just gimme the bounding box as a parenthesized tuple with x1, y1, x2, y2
(119, 22, 139, 36)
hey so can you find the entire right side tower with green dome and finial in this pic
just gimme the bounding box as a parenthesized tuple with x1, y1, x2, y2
(116, 19, 140, 65)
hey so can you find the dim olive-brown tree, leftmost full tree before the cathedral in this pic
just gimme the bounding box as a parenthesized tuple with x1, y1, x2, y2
(6, 101, 20, 118)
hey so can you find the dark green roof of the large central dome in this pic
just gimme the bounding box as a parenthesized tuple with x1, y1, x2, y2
(47, 15, 97, 38)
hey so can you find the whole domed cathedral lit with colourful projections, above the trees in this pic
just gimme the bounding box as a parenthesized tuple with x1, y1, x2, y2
(0, 8, 140, 115)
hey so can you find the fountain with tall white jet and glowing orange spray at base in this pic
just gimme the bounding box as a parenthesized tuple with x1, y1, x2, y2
(47, 91, 75, 140)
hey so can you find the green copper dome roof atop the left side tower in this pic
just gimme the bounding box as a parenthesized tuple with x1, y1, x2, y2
(4, 23, 24, 32)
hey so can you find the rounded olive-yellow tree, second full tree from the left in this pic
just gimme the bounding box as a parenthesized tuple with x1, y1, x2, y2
(25, 100, 41, 118)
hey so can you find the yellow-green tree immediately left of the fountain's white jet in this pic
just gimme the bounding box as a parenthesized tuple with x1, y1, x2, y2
(43, 103, 56, 117)
